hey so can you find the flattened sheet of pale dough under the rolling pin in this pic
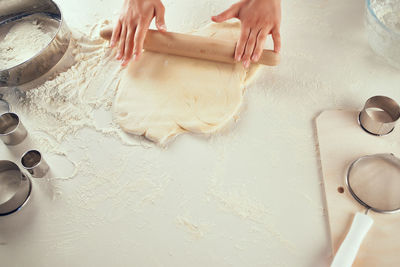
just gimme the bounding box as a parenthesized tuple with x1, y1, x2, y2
(114, 22, 258, 144)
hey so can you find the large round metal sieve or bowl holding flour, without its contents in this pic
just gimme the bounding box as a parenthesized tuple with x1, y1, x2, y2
(0, 0, 71, 87)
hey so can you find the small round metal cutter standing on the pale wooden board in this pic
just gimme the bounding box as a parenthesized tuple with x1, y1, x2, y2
(358, 96, 400, 136)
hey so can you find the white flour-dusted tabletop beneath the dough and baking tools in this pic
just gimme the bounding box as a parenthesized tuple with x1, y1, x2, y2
(0, 0, 400, 267)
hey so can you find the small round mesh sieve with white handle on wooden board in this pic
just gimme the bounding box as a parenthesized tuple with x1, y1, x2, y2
(331, 154, 400, 267)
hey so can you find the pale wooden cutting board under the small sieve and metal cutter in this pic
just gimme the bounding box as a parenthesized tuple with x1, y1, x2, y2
(316, 110, 400, 267)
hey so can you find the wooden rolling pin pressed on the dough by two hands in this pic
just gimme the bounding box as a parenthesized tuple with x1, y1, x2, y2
(100, 27, 279, 66)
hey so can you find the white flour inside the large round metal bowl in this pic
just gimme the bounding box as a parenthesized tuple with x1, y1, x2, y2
(0, 15, 57, 69)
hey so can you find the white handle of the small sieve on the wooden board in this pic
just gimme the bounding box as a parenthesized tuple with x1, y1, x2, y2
(331, 212, 374, 267)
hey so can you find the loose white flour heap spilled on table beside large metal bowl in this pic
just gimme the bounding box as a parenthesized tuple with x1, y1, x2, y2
(6, 21, 130, 143)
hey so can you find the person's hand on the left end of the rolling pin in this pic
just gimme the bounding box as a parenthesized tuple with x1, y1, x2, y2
(111, 0, 167, 66)
